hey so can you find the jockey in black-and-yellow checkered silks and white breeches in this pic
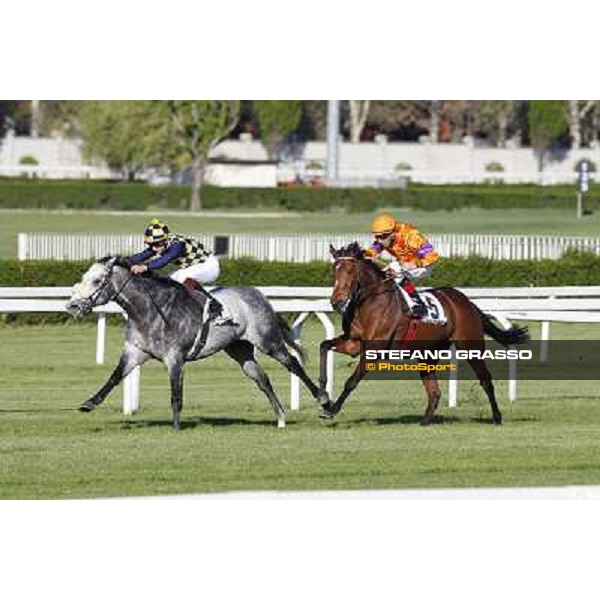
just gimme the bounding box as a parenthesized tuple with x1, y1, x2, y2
(129, 219, 234, 325)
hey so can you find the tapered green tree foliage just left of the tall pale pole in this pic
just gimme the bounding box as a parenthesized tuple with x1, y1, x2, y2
(254, 100, 302, 160)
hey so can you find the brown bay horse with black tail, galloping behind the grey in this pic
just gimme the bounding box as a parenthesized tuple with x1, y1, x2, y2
(319, 242, 529, 425)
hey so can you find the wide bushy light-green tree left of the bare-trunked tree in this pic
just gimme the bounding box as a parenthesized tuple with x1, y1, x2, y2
(78, 100, 169, 179)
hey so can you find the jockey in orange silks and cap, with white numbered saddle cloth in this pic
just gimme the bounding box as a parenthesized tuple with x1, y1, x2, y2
(365, 214, 443, 323)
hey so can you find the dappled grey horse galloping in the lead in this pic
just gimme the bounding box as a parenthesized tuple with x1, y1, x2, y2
(66, 256, 330, 430)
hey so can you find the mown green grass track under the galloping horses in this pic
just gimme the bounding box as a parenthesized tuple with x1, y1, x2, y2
(0, 323, 600, 499)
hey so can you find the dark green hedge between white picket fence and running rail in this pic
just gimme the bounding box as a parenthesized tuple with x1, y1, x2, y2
(0, 252, 600, 287)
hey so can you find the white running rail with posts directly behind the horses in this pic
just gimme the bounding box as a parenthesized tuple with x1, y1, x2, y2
(0, 286, 600, 414)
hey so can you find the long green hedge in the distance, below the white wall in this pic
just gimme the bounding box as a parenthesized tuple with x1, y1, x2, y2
(0, 179, 600, 212)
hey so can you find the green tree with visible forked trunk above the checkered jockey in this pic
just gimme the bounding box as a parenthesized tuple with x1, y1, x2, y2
(164, 100, 240, 210)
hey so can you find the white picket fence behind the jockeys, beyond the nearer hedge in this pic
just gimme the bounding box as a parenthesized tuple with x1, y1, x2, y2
(18, 233, 600, 262)
